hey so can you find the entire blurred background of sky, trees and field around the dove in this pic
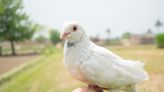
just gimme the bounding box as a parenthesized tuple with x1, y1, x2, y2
(0, 0, 164, 92)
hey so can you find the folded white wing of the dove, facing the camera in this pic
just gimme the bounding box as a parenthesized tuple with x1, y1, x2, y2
(80, 45, 148, 88)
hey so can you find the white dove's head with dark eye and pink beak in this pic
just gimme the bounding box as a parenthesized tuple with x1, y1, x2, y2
(60, 21, 85, 41)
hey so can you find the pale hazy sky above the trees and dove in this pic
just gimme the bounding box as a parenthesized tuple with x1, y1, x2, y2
(23, 0, 164, 38)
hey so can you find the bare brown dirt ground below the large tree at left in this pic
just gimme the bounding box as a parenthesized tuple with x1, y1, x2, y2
(0, 55, 38, 75)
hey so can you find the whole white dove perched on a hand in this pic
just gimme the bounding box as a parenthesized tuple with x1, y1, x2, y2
(60, 21, 148, 92)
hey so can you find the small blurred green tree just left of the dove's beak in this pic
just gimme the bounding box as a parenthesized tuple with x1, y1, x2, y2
(50, 30, 61, 44)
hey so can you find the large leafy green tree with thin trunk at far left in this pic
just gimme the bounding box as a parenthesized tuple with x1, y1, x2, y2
(0, 0, 36, 55)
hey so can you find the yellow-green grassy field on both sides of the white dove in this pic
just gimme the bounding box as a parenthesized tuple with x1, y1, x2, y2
(0, 46, 164, 92)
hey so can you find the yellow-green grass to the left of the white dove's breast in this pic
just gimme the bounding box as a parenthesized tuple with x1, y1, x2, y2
(0, 48, 83, 92)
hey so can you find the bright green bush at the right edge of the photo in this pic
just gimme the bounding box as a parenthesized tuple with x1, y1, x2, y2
(156, 33, 164, 48)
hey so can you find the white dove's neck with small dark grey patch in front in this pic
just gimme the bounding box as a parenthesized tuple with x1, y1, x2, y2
(64, 34, 92, 62)
